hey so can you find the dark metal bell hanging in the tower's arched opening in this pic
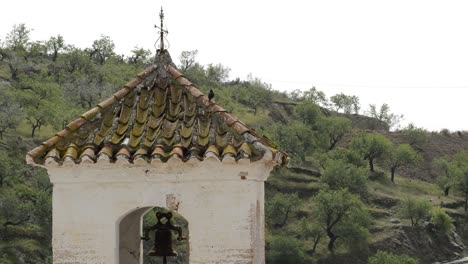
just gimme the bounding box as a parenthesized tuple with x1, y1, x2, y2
(142, 212, 185, 263)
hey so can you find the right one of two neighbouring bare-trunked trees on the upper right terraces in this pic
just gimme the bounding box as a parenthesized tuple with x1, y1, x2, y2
(388, 144, 420, 182)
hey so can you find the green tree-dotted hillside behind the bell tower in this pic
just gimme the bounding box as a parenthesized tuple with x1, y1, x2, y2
(0, 24, 468, 264)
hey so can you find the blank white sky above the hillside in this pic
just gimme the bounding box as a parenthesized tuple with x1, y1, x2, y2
(0, 0, 468, 130)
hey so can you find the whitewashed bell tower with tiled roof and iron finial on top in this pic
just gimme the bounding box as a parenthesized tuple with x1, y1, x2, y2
(26, 8, 287, 264)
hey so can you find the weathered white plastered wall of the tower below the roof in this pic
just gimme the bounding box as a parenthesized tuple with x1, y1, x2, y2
(47, 159, 273, 264)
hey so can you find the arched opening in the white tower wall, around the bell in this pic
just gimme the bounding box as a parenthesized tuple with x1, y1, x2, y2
(118, 207, 189, 264)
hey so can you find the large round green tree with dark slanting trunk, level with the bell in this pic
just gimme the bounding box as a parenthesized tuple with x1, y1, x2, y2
(314, 189, 370, 254)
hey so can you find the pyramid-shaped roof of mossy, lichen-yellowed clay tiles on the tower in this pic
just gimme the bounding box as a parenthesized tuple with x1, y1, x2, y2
(27, 51, 287, 165)
